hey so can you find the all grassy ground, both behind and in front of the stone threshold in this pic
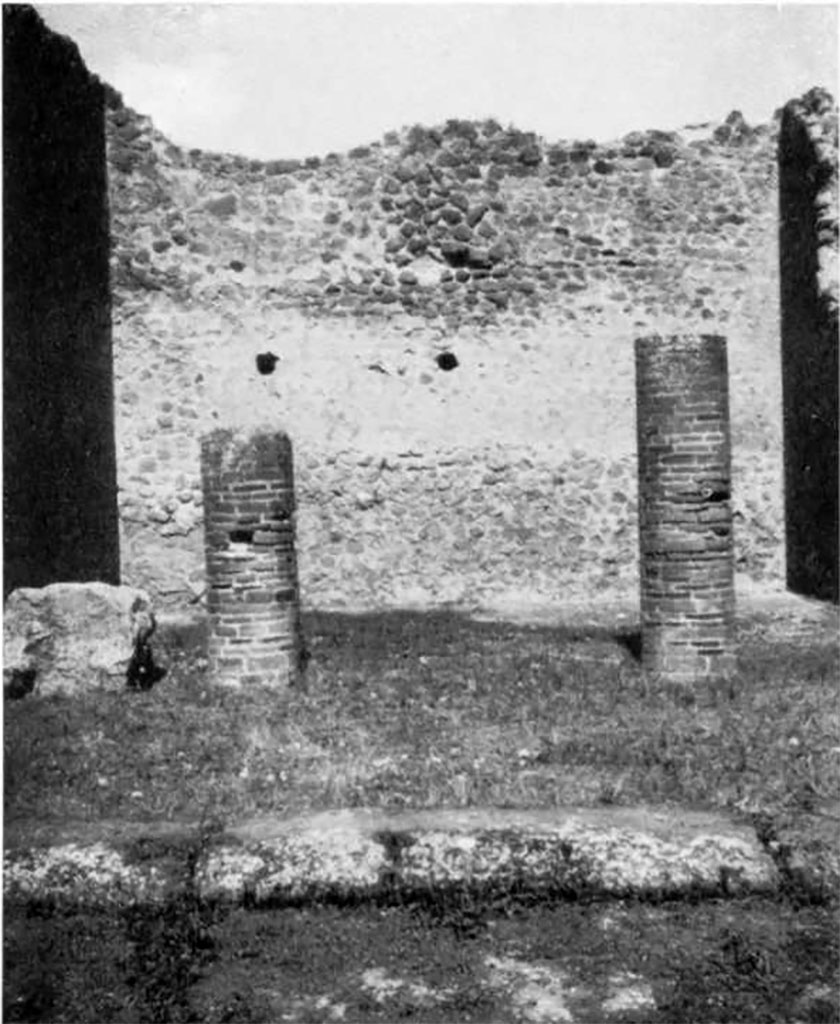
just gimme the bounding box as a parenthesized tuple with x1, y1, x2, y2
(3, 612, 840, 1024)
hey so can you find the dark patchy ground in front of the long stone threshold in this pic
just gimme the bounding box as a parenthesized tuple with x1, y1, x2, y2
(3, 898, 840, 1024)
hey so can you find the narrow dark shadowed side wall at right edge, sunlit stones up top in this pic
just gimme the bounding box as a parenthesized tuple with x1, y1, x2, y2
(779, 89, 840, 601)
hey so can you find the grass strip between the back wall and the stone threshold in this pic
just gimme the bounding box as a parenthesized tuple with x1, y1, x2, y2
(4, 612, 840, 829)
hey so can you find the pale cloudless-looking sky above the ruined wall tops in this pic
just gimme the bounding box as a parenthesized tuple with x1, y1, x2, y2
(36, 2, 838, 159)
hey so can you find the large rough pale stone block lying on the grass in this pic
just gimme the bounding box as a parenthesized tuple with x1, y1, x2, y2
(3, 583, 155, 696)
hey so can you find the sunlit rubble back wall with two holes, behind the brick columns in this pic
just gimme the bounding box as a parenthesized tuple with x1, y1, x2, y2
(96, 90, 819, 606)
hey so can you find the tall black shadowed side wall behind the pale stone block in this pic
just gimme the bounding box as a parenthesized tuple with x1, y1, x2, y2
(3, 4, 120, 594)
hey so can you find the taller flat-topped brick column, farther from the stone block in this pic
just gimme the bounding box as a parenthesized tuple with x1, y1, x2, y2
(636, 335, 734, 686)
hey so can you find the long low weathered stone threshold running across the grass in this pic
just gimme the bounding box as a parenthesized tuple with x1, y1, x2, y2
(3, 808, 781, 906)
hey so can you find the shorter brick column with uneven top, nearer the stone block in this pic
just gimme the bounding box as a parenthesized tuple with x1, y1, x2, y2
(201, 430, 302, 688)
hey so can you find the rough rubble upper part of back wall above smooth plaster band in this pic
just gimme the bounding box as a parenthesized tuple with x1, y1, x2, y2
(109, 96, 775, 333)
